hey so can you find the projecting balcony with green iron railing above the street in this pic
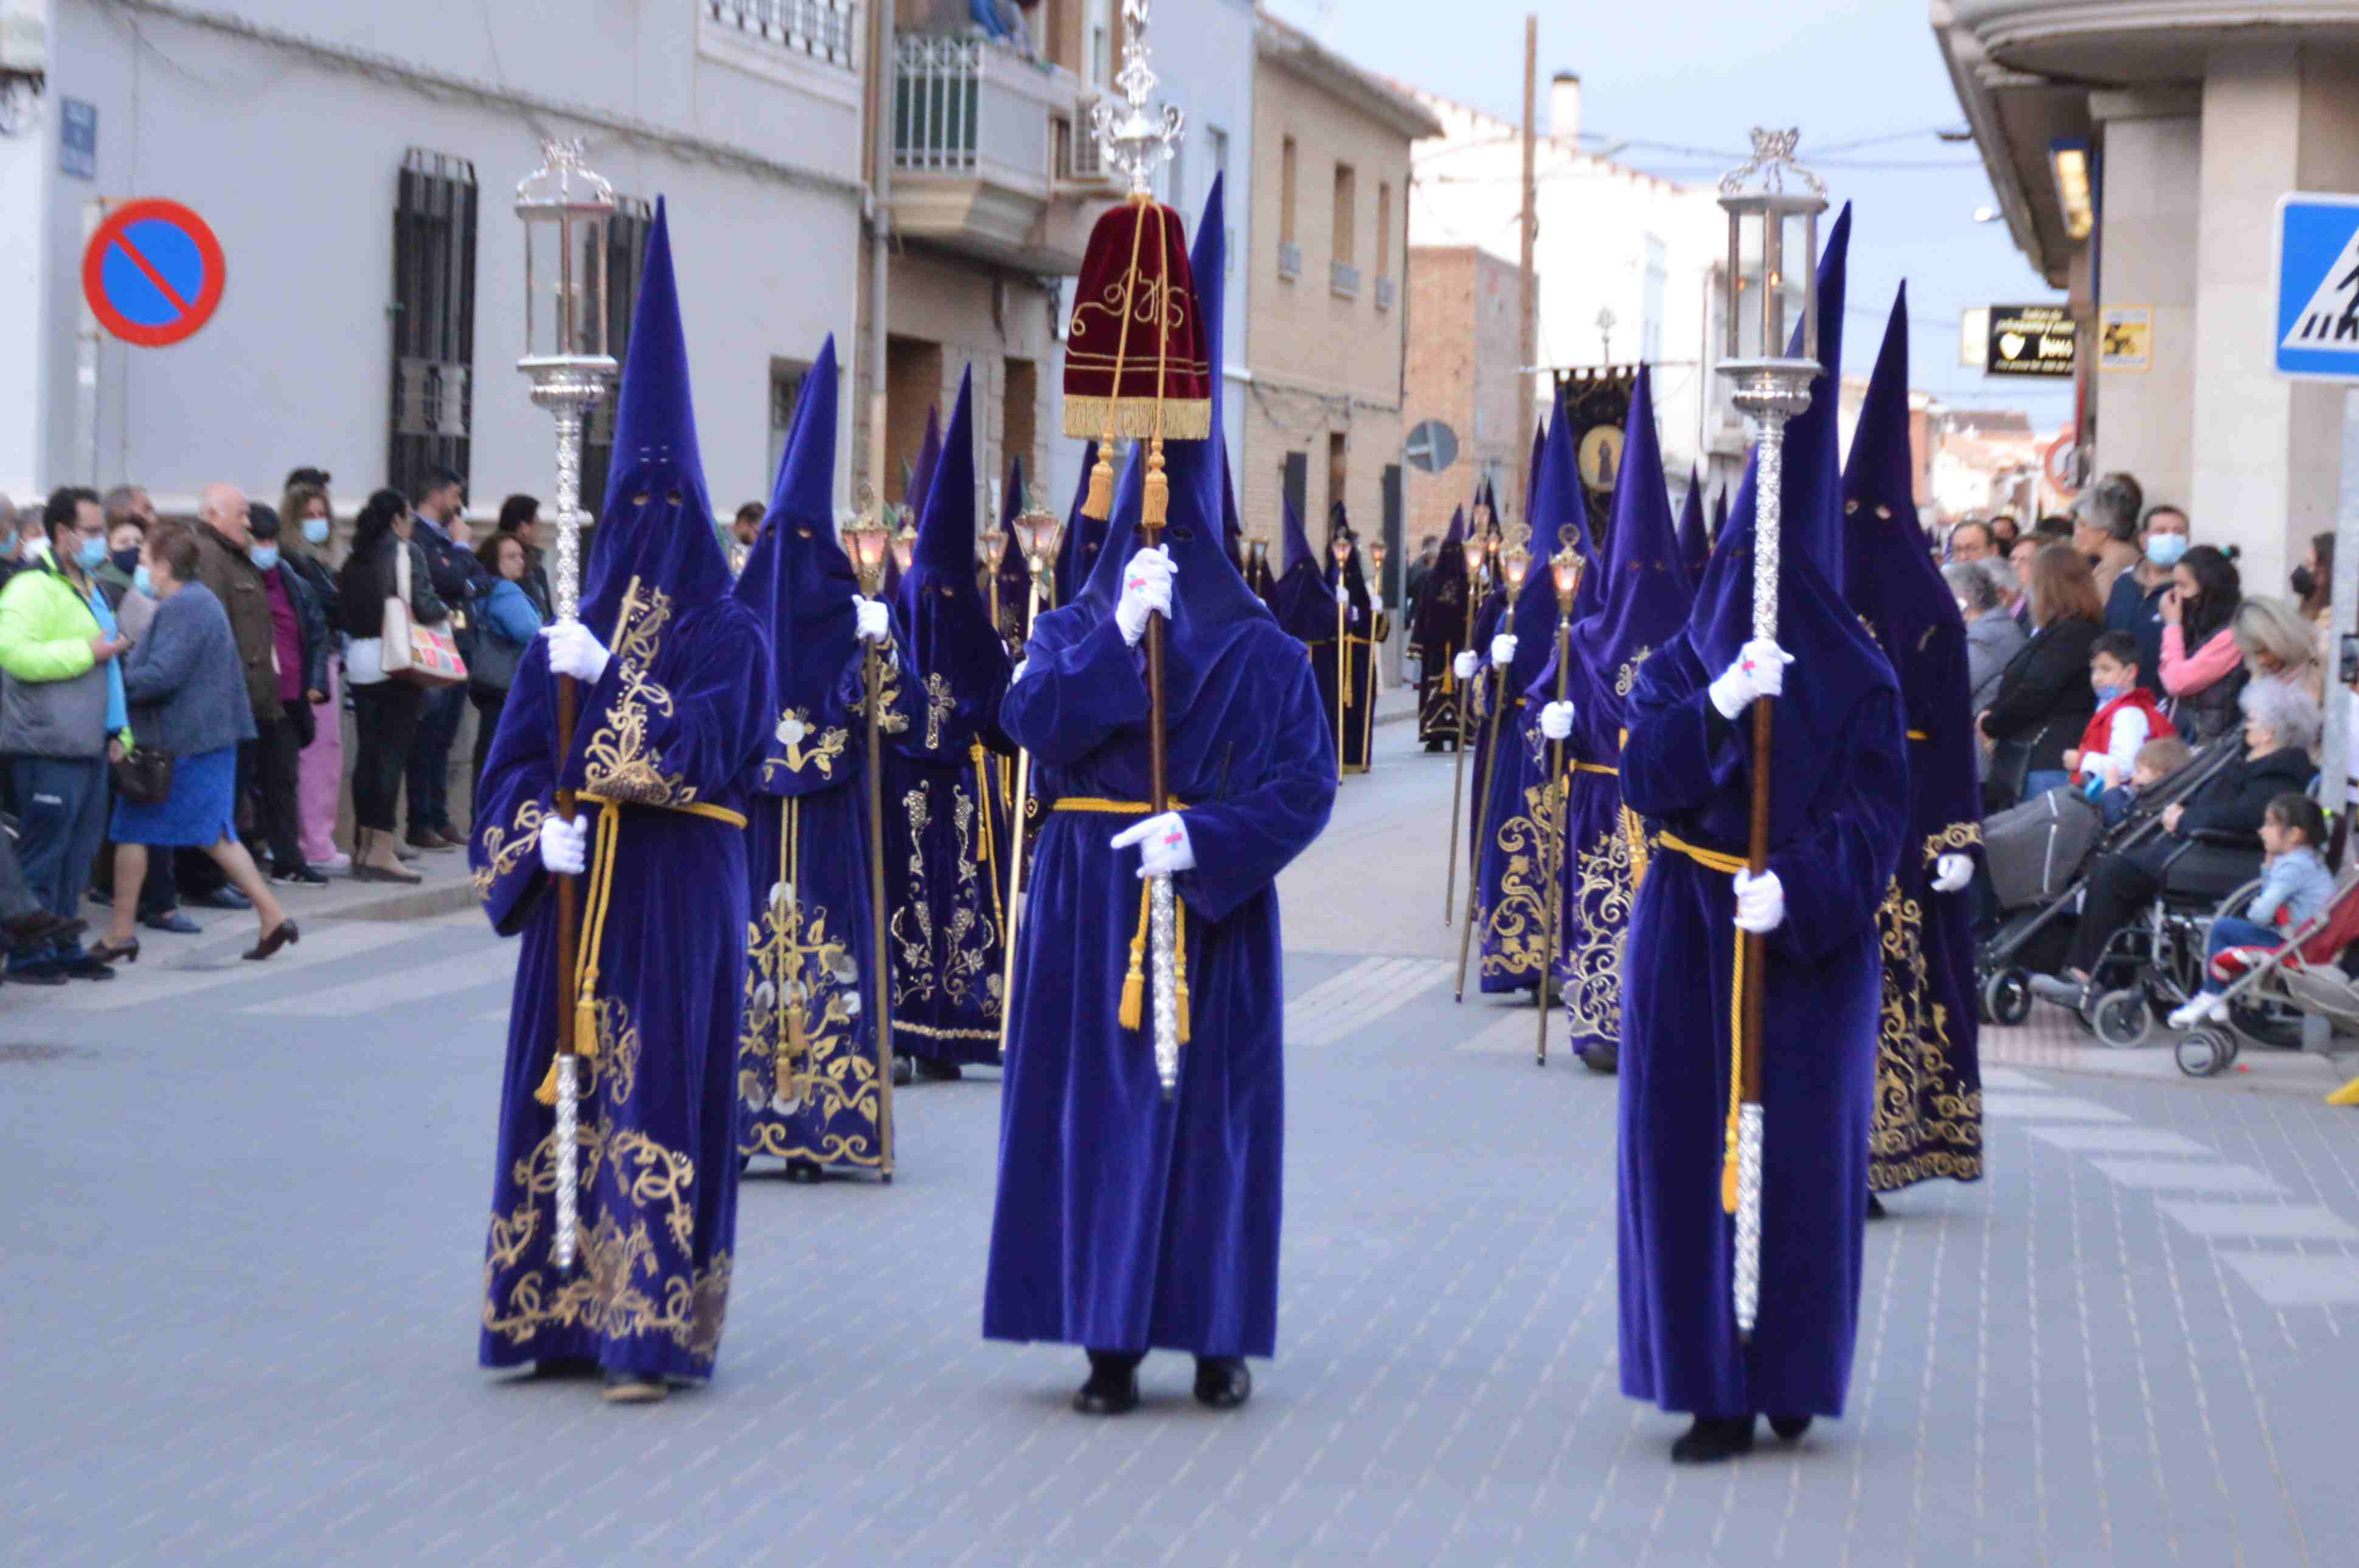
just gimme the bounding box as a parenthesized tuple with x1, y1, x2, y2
(892, 33, 1116, 274)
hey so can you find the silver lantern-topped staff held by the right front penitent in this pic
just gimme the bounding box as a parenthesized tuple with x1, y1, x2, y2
(1720, 127, 1826, 1339)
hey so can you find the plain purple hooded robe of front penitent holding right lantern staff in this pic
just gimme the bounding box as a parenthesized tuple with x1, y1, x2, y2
(1618, 215, 1908, 1417)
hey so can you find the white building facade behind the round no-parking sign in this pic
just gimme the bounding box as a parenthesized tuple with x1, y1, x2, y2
(0, 0, 868, 516)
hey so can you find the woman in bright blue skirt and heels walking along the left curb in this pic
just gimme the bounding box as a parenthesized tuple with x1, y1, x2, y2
(92, 528, 302, 965)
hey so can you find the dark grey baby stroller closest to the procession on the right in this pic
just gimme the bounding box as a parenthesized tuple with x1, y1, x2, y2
(1975, 736, 2243, 1025)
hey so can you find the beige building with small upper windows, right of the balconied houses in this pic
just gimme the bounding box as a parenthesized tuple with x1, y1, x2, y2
(1236, 14, 1439, 603)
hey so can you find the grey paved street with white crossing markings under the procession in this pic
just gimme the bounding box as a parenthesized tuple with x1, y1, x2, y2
(0, 724, 2359, 1568)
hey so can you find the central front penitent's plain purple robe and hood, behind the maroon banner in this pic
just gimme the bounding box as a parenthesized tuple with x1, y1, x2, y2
(984, 179, 1335, 1356)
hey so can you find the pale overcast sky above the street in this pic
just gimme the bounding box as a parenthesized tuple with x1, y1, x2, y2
(1274, 0, 2071, 429)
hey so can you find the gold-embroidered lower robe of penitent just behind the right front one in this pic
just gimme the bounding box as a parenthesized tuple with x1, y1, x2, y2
(1868, 882, 1982, 1193)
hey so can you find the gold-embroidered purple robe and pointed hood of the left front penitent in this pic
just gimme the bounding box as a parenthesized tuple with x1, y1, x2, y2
(472, 205, 771, 1379)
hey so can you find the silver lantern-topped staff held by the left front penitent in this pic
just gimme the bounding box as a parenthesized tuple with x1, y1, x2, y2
(516, 139, 616, 1269)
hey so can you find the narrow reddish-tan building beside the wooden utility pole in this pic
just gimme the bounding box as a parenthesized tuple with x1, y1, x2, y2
(1406, 245, 1524, 552)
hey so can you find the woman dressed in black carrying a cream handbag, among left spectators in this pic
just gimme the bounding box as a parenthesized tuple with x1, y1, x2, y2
(339, 490, 451, 882)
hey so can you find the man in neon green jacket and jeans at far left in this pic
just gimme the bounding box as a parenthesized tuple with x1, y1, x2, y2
(0, 486, 130, 983)
